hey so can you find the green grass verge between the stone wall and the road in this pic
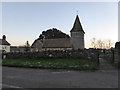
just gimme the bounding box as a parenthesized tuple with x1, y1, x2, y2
(2, 59, 97, 70)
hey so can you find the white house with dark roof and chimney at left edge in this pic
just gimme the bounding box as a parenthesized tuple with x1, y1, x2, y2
(0, 35, 10, 52)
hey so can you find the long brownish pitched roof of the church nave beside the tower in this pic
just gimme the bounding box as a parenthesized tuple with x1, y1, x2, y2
(43, 38, 71, 48)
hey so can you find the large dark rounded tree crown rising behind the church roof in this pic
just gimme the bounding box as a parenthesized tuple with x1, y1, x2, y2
(39, 28, 69, 39)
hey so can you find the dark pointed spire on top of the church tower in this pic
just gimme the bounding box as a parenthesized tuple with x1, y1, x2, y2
(70, 15, 84, 32)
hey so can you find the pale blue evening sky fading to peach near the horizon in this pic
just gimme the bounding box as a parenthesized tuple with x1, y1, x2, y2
(0, 2, 118, 48)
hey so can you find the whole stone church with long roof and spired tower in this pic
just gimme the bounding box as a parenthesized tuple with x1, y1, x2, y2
(31, 15, 85, 52)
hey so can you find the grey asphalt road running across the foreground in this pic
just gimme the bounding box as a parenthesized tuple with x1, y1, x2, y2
(2, 67, 118, 90)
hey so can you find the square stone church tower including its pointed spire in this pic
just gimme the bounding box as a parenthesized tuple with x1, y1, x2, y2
(70, 15, 85, 50)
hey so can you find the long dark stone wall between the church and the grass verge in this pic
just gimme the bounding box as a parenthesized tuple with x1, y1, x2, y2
(3, 50, 98, 61)
